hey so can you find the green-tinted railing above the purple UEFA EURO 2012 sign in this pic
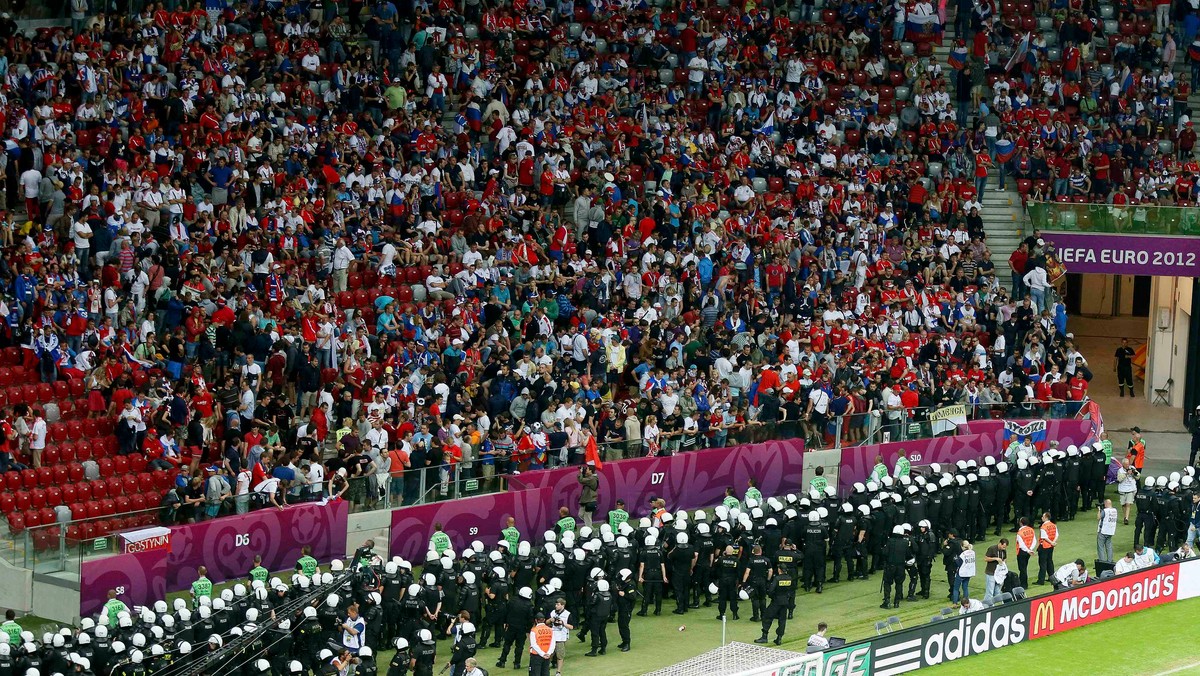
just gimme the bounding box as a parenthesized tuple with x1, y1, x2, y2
(1026, 202, 1200, 235)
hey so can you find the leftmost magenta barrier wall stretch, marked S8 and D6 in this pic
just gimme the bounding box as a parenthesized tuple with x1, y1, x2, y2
(79, 501, 349, 616)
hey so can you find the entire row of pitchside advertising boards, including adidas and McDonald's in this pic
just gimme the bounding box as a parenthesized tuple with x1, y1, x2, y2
(782, 558, 1200, 676)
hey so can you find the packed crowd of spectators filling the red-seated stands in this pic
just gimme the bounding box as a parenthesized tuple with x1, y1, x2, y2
(0, 1, 1180, 521)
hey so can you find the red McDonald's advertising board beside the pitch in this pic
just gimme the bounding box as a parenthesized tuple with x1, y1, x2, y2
(1030, 562, 1196, 640)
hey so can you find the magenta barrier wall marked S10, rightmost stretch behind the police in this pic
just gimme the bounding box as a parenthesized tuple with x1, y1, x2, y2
(838, 420, 1092, 495)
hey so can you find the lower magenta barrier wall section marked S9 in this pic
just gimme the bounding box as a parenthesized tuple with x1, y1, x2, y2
(388, 489, 558, 566)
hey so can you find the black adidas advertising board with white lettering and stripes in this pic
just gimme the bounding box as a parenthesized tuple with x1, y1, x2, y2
(870, 600, 1030, 676)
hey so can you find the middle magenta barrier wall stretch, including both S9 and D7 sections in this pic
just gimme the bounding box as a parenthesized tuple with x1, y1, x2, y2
(390, 439, 804, 563)
